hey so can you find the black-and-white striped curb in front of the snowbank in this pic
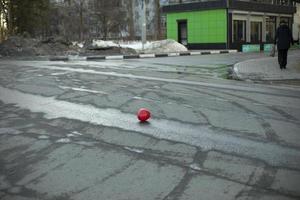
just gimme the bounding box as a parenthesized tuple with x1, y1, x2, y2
(49, 50, 238, 61)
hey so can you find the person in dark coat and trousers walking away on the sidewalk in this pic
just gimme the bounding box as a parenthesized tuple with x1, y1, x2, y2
(274, 21, 294, 69)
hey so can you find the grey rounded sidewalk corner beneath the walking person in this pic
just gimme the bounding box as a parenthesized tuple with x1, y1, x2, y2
(233, 50, 300, 80)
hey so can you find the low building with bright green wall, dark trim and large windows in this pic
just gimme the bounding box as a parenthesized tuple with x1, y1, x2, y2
(163, 0, 297, 51)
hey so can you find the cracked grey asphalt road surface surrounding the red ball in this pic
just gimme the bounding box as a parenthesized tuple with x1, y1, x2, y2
(0, 53, 300, 200)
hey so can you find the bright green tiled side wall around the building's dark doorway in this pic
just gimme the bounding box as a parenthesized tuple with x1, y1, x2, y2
(167, 9, 227, 43)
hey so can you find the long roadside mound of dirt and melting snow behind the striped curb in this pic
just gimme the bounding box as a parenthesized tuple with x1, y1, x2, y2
(0, 36, 187, 56)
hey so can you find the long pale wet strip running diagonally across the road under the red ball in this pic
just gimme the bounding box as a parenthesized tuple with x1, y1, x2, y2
(0, 87, 300, 169)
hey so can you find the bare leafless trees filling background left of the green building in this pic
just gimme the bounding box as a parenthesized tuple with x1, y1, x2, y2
(0, 0, 161, 41)
